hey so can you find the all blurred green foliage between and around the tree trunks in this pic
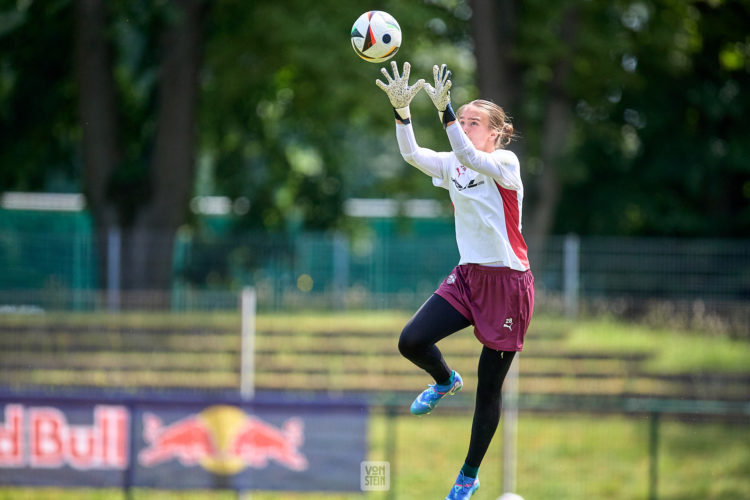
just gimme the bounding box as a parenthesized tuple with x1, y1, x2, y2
(0, 0, 750, 237)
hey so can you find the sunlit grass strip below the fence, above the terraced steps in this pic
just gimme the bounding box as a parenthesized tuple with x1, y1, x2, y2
(3, 311, 750, 373)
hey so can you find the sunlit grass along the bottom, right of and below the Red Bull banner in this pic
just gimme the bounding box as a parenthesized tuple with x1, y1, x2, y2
(0, 411, 750, 500)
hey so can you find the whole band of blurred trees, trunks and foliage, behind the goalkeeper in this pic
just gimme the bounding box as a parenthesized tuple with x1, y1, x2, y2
(0, 0, 750, 287)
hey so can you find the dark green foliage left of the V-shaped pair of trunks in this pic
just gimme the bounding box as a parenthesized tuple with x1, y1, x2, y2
(0, 0, 82, 191)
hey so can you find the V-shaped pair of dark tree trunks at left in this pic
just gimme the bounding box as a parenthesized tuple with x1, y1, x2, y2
(76, 0, 207, 299)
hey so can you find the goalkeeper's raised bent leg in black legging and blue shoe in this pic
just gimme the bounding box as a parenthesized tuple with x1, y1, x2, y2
(398, 295, 470, 415)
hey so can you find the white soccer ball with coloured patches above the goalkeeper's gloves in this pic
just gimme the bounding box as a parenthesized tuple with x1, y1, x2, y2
(352, 10, 401, 63)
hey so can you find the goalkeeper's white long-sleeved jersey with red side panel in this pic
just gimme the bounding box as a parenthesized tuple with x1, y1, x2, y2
(396, 122, 529, 271)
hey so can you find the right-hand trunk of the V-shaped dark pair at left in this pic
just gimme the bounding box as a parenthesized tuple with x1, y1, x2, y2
(123, 0, 205, 290)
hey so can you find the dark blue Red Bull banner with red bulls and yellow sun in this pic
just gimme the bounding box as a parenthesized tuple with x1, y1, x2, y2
(0, 398, 368, 491)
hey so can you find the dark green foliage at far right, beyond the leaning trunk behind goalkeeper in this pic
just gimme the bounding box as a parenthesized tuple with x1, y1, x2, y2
(556, 0, 750, 237)
